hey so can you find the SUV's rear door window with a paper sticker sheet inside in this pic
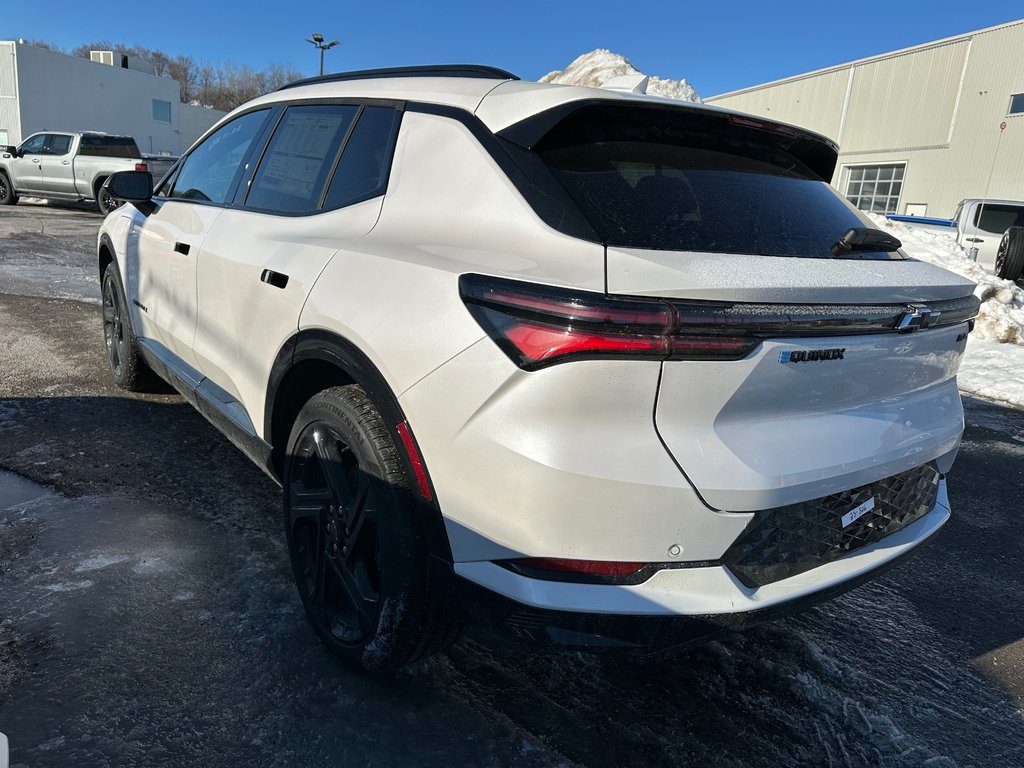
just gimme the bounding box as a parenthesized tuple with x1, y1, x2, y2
(246, 104, 358, 213)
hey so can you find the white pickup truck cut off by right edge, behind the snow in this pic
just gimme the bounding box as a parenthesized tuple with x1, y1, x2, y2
(886, 199, 1024, 280)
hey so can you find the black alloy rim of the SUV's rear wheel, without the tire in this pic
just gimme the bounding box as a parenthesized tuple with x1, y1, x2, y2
(287, 422, 381, 649)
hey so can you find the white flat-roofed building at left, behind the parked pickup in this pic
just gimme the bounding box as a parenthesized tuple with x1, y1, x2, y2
(0, 41, 224, 155)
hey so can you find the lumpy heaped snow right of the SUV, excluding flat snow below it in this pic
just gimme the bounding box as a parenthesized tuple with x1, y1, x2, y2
(868, 214, 1024, 344)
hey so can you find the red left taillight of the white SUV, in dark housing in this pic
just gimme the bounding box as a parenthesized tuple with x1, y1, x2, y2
(459, 274, 760, 371)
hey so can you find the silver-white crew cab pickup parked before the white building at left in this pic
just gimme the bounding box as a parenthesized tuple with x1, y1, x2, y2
(0, 131, 148, 214)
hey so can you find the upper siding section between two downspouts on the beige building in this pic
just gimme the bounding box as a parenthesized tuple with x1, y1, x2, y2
(843, 40, 970, 152)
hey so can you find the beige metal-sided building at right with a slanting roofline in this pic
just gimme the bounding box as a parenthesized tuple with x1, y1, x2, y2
(705, 19, 1024, 216)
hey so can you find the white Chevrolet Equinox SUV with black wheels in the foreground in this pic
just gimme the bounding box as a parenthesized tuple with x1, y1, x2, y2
(98, 66, 978, 671)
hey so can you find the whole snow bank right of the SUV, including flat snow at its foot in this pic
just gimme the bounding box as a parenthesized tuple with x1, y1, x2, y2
(868, 214, 1024, 408)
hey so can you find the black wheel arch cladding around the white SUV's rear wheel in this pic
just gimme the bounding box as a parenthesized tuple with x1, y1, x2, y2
(263, 330, 452, 562)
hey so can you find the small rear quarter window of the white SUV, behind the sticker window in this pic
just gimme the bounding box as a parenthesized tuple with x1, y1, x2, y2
(324, 106, 400, 209)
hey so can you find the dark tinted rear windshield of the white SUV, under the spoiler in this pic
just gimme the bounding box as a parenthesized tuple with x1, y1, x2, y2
(535, 106, 888, 259)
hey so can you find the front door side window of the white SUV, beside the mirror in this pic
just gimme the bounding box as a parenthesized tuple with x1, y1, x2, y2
(168, 110, 268, 203)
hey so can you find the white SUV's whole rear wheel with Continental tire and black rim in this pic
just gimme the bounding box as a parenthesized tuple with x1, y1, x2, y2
(284, 385, 458, 673)
